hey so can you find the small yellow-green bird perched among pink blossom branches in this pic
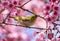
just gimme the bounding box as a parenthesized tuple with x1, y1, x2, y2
(14, 14, 37, 26)
